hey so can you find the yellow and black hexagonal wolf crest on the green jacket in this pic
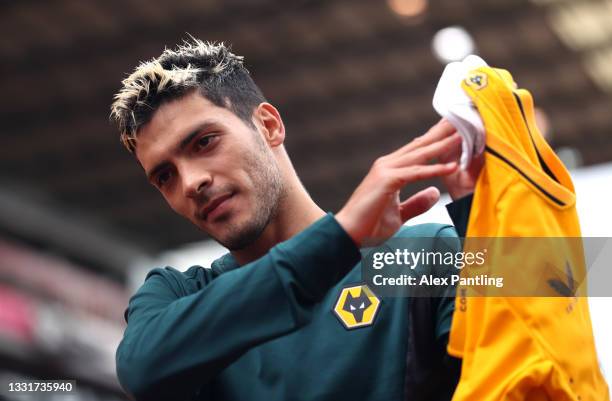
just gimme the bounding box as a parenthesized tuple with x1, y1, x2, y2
(334, 284, 380, 329)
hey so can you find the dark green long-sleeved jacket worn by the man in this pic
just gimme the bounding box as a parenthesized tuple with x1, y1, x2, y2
(116, 214, 459, 401)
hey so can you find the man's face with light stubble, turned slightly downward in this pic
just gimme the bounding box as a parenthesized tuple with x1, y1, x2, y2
(136, 91, 284, 250)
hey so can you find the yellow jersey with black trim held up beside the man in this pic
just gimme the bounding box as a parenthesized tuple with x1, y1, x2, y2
(448, 67, 609, 401)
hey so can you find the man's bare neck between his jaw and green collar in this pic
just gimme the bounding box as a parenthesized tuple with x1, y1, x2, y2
(232, 182, 325, 265)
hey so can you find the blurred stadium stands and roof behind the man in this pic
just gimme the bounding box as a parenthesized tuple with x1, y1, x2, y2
(0, 0, 612, 401)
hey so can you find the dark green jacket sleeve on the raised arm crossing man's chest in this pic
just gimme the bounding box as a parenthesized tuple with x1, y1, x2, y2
(116, 215, 360, 400)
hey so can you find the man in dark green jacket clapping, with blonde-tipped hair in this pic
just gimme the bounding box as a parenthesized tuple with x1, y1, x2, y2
(112, 39, 478, 400)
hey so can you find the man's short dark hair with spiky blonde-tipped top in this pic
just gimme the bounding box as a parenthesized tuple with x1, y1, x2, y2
(111, 37, 266, 153)
